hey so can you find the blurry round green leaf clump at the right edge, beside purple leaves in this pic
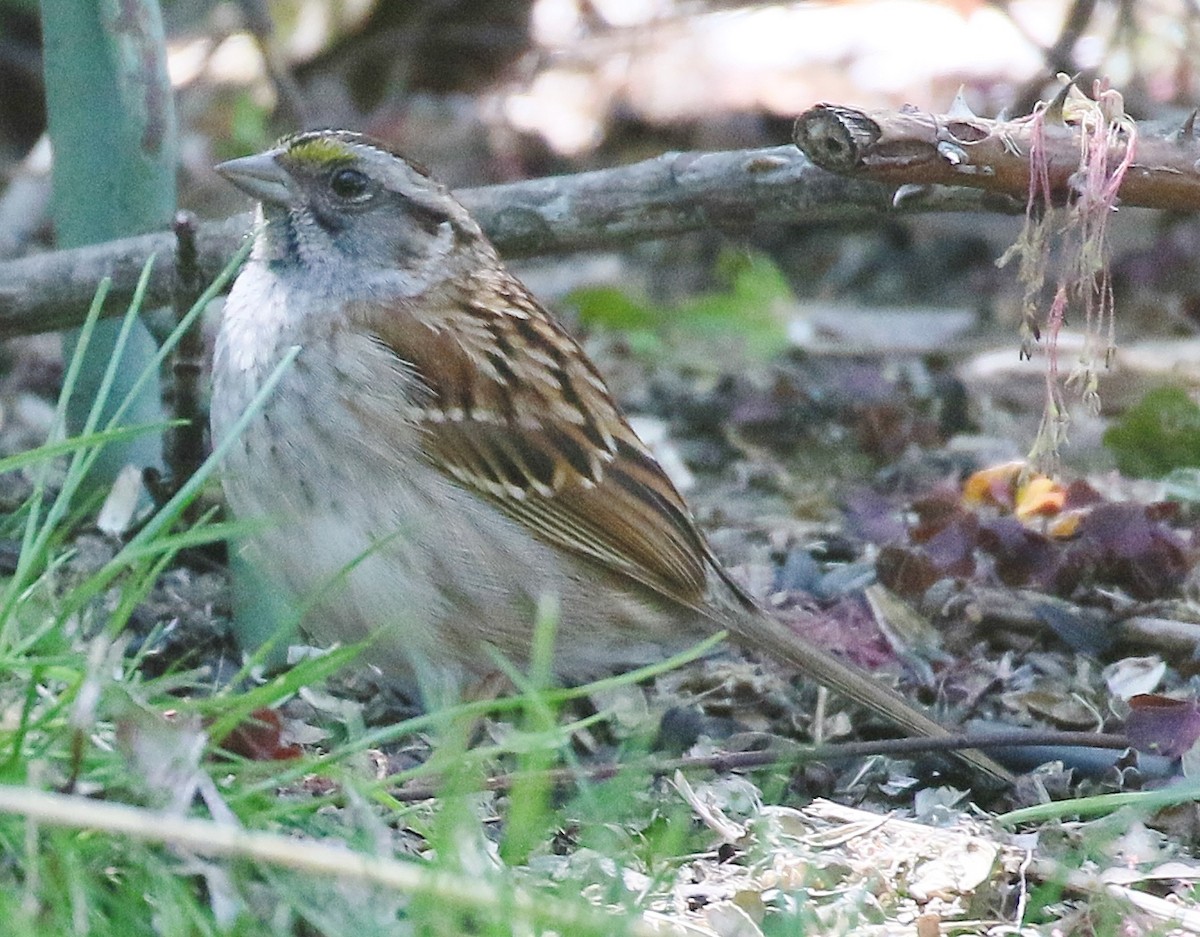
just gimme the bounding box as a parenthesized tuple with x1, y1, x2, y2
(1104, 388, 1200, 477)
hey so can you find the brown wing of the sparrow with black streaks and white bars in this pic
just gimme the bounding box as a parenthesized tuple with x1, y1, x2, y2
(360, 271, 708, 609)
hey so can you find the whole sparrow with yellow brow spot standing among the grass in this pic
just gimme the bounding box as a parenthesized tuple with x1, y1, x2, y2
(212, 131, 1007, 777)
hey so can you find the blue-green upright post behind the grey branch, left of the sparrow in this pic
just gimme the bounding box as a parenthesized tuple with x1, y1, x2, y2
(42, 0, 176, 487)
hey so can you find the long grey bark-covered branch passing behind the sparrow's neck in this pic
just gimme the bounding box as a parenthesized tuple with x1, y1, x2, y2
(0, 146, 1003, 338)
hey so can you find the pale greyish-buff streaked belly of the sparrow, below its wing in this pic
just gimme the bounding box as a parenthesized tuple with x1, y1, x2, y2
(212, 301, 714, 695)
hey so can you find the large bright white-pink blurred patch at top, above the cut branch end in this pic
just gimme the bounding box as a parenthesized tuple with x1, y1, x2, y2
(506, 0, 1089, 152)
